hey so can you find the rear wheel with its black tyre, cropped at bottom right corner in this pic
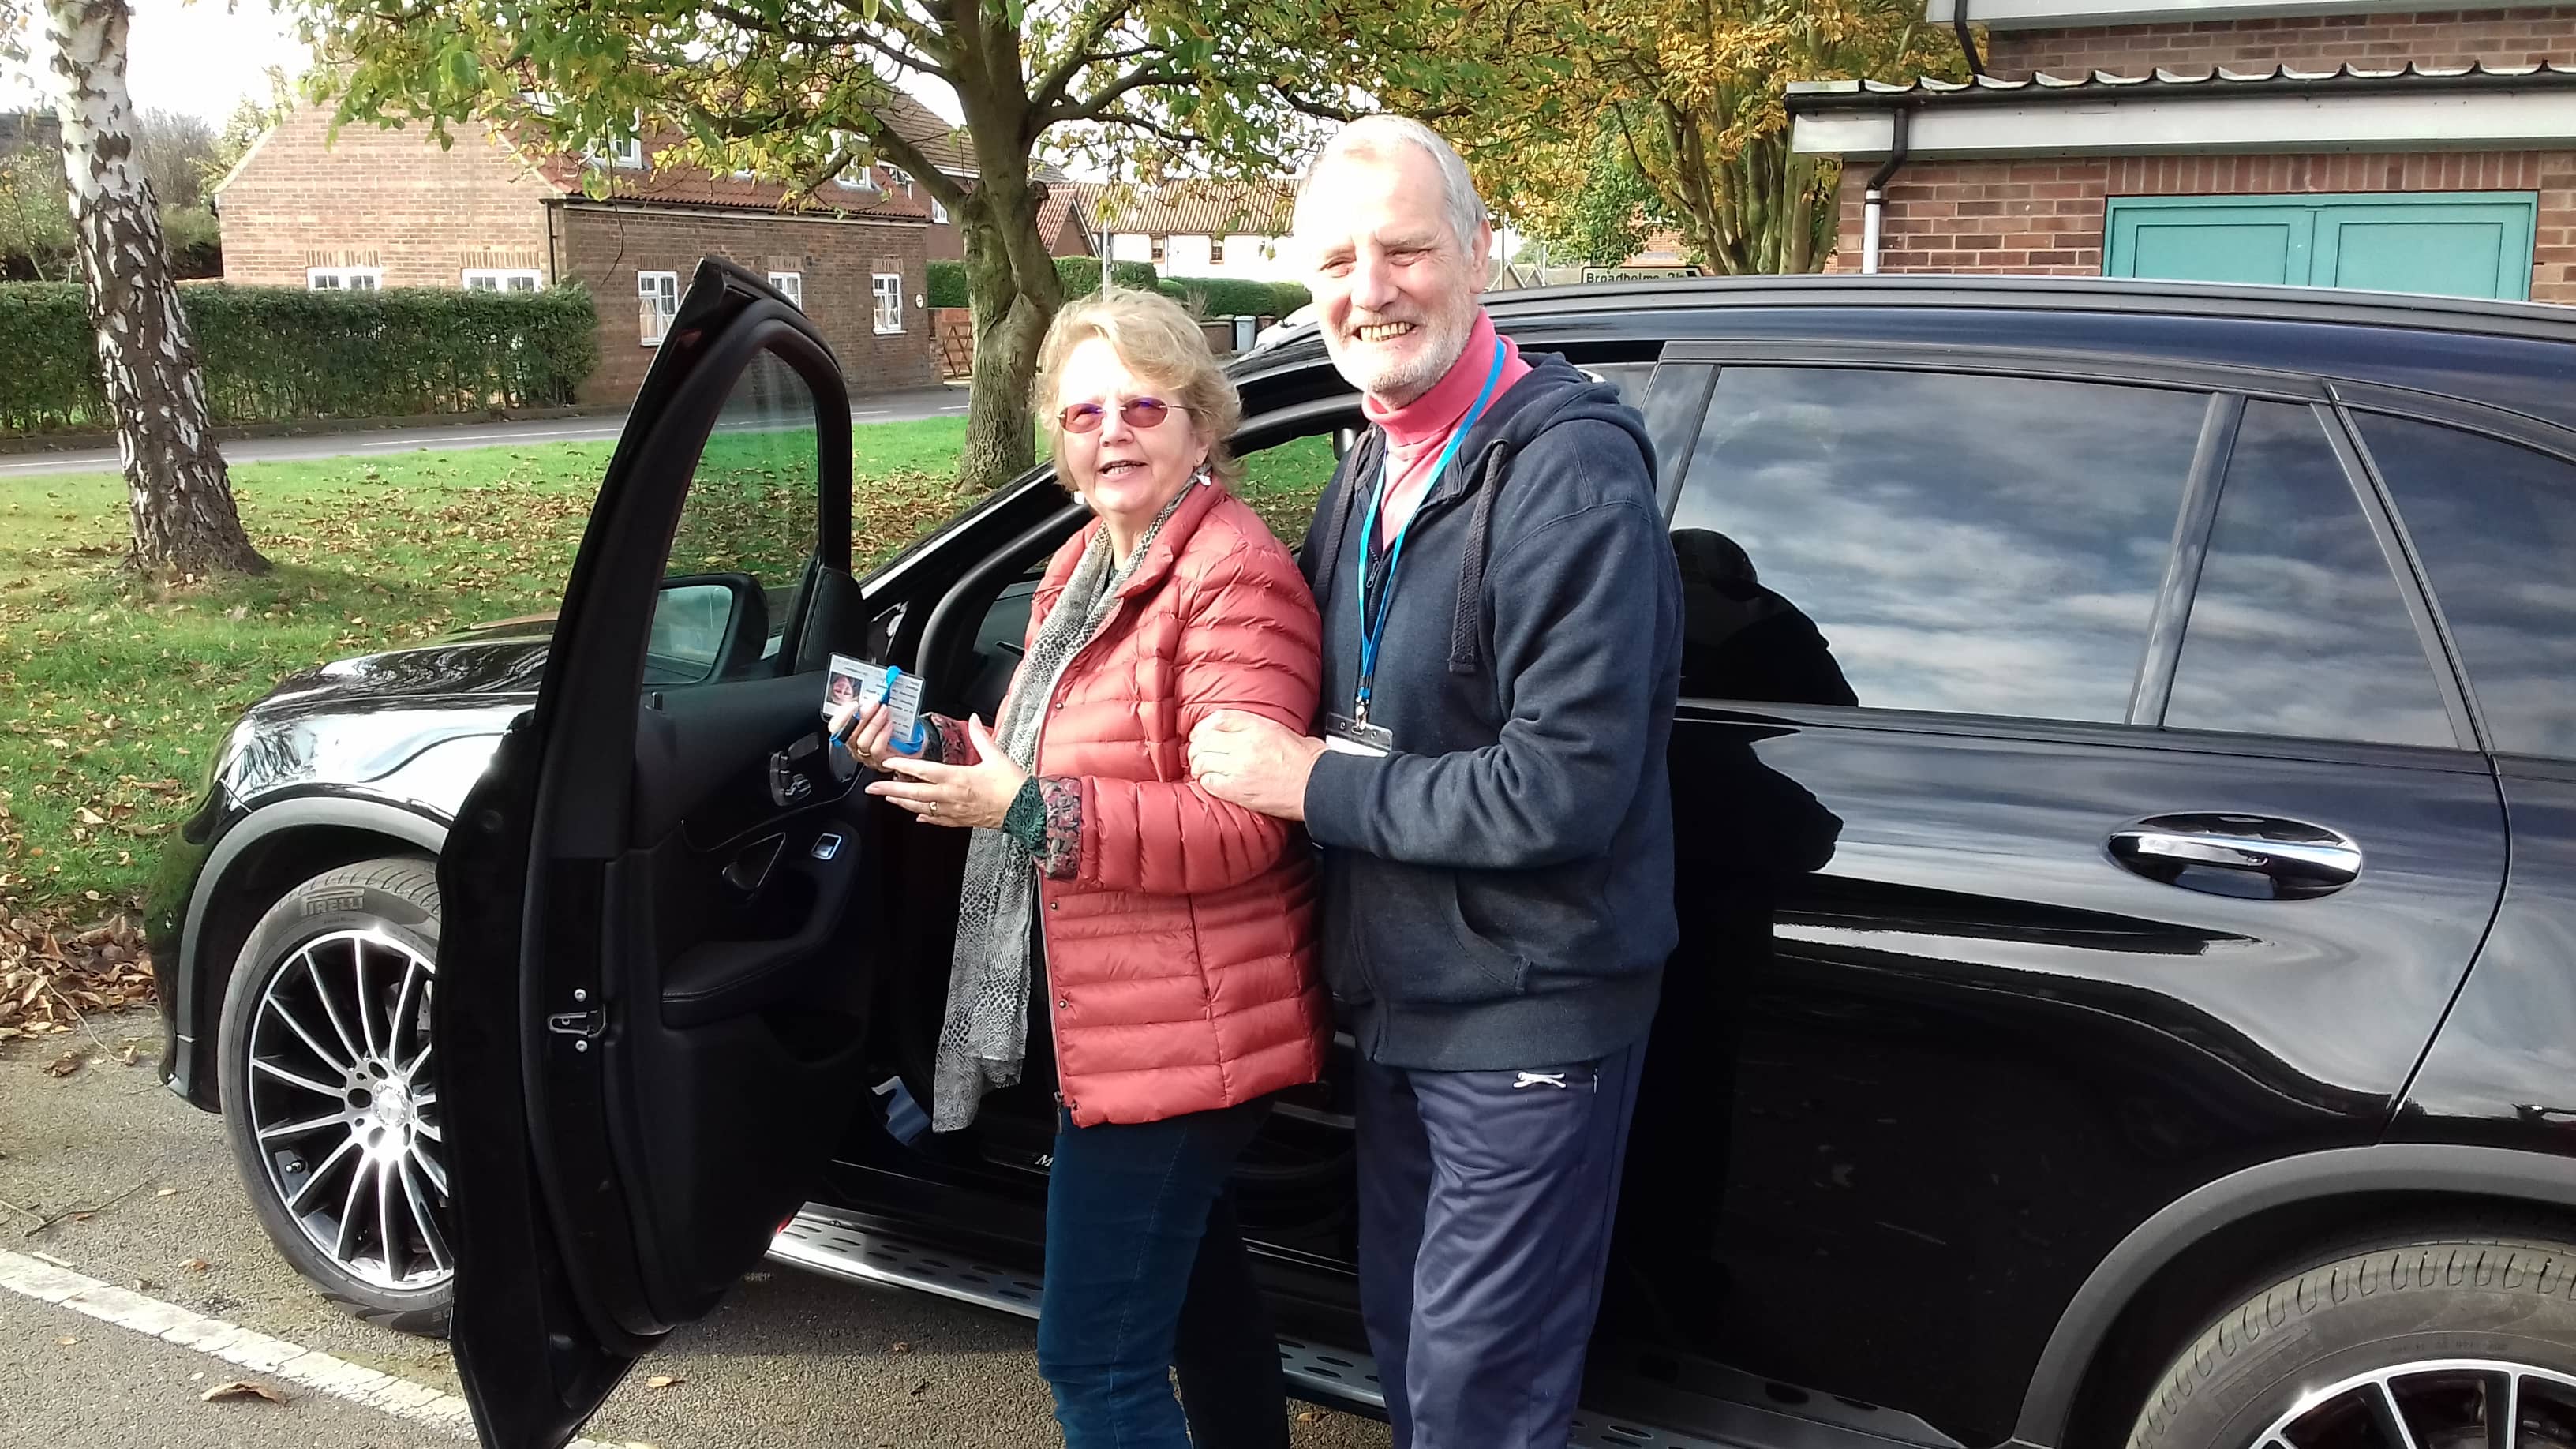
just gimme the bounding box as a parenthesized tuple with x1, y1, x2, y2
(2128, 1237, 2576, 1449)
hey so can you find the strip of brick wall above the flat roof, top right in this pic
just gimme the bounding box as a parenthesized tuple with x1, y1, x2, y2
(1986, 6, 2576, 77)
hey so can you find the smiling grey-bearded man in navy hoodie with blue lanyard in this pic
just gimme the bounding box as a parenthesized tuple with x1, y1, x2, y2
(1190, 116, 1682, 1449)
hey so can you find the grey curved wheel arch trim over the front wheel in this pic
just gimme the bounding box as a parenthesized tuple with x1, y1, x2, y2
(170, 796, 448, 1111)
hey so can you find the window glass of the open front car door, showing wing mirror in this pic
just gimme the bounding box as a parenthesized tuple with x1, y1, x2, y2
(644, 354, 822, 686)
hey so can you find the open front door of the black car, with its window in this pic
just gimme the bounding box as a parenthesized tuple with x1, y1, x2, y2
(432, 260, 876, 1449)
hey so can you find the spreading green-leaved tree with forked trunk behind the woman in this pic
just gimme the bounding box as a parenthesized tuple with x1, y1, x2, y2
(289, 0, 1391, 487)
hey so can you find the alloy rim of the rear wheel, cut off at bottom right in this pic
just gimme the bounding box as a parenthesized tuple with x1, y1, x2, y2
(2254, 1359, 2576, 1449)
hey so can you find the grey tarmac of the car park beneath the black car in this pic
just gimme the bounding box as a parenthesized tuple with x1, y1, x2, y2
(0, 1016, 1388, 1449)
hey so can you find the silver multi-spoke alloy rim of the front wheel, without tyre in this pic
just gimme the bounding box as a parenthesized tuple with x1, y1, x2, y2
(250, 930, 456, 1292)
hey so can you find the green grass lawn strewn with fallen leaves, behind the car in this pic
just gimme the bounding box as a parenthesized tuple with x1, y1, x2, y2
(0, 417, 1331, 923)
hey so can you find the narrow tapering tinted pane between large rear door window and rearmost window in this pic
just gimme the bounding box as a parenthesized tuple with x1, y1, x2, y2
(2164, 402, 2452, 745)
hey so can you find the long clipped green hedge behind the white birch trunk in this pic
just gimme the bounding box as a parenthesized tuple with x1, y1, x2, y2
(0, 281, 601, 433)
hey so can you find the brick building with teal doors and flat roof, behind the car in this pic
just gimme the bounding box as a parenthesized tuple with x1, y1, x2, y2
(1788, 0, 2576, 301)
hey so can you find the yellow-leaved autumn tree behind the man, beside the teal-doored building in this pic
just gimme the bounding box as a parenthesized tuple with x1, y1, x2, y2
(1442, 0, 1965, 276)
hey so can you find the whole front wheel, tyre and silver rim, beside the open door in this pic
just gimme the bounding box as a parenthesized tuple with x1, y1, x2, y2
(216, 856, 456, 1335)
